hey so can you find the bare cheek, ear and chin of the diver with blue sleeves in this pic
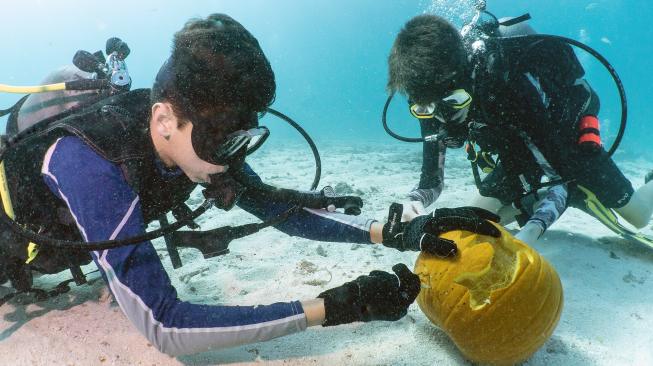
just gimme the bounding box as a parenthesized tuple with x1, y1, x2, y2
(150, 103, 227, 183)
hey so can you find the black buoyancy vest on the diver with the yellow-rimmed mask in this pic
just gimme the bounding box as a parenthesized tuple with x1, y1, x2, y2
(464, 17, 599, 194)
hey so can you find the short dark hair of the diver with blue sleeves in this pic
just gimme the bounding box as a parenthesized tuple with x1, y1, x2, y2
(151, 14, 276, 123)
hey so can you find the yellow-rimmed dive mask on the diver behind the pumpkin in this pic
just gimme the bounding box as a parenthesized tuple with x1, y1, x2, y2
(410, 89, 472, 124)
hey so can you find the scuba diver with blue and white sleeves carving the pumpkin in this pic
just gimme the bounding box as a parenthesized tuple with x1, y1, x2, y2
(0, 14, 500, 355)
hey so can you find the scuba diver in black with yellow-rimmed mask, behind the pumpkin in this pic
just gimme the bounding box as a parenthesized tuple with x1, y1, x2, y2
(383, 12, 653, 246)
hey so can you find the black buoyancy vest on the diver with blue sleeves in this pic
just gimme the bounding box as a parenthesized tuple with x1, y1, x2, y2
(0, 89, 196, 273)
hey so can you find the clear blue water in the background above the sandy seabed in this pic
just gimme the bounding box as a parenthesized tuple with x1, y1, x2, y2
(0, 0, 653, 157)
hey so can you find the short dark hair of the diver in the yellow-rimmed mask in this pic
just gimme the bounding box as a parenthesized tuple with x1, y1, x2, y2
(387, 14, 467, 104)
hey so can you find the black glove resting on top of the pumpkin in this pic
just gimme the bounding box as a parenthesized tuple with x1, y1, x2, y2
(383, 203, 501, 257)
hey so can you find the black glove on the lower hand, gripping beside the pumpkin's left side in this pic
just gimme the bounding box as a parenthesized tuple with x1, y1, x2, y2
(317, 263, 421, 327)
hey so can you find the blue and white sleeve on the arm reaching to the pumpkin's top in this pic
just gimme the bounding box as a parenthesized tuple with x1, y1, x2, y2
(238, 165, 375, 244)
